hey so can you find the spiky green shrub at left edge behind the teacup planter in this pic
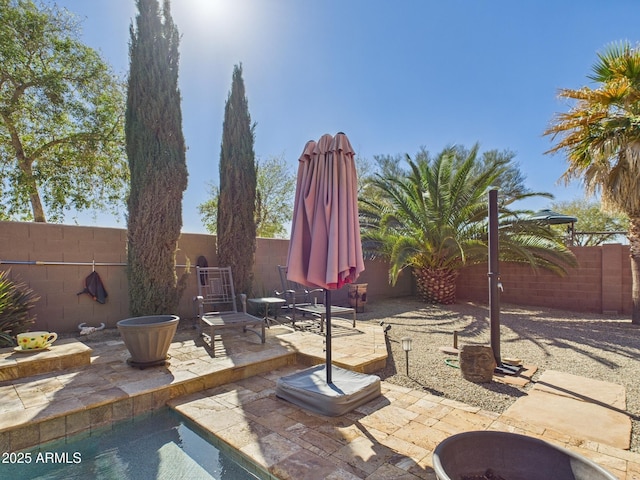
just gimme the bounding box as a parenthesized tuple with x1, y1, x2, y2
(0, 270, 40, 347)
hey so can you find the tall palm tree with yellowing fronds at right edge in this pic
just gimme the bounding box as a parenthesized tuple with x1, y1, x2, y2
(545, 42, 640, 324)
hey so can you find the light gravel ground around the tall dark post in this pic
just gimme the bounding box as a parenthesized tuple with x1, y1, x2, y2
(358, 298, 640, 452)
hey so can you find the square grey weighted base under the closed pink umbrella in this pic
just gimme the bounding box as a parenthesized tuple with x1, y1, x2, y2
(276, 365, 382, 417)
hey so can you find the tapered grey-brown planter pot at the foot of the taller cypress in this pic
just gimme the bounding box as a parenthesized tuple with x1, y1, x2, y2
(116, 315, 180, 368)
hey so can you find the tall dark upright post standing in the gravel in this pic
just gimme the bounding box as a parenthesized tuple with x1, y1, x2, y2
(488, 190, 502, 365)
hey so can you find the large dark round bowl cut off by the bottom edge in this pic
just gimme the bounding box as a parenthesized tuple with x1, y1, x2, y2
(433, 431, 616, 480)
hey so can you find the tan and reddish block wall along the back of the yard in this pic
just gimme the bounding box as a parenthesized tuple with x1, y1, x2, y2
(0, 222, 632, 332)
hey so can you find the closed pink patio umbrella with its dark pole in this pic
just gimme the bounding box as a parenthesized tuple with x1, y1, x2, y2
(287, 132, 364, 383)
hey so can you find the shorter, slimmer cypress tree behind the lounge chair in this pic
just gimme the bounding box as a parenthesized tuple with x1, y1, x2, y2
(217, 65, 257, 294)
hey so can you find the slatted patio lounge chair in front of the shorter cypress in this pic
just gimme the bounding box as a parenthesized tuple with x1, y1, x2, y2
(195, 267, 265, 357)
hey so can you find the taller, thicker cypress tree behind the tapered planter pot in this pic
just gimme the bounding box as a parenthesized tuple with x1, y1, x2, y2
(125, 0, 187, 316)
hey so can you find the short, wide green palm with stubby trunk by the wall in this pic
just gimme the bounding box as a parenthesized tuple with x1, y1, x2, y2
(360, 145, 576, 304)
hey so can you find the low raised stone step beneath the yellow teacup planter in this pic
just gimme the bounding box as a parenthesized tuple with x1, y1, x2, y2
(0, 338, 93, 382)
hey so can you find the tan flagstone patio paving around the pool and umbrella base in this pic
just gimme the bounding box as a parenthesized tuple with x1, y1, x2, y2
(0, 319, 640, 480)
